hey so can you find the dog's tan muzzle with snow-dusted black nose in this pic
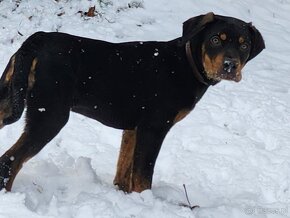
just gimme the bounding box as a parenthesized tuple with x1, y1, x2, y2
(203, 54, 244, 82)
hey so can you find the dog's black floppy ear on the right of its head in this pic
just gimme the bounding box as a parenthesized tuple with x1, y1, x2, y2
(247, 23, 265, 61)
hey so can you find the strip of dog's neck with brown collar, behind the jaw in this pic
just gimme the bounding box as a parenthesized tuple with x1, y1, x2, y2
(185, 41, 218, 86)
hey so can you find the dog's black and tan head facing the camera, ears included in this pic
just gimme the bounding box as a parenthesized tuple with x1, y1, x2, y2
(182, 13, 265, 82)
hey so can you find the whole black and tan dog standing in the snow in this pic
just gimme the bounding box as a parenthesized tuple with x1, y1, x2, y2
(0, 13, 265, 192)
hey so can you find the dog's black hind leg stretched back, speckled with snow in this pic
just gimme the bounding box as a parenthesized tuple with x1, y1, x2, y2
(0, 91, 70, 191)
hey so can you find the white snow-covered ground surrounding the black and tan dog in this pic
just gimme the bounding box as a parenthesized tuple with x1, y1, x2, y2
(0, 0, 290, 218)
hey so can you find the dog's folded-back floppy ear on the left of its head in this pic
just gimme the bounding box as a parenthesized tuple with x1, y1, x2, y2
(181, 12, 214, 44)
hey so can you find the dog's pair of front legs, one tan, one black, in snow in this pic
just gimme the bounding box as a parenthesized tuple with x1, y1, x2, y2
(114, 125, 170, 193)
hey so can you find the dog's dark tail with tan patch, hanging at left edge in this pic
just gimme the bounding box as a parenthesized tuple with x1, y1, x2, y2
(0, 48, 35, 128)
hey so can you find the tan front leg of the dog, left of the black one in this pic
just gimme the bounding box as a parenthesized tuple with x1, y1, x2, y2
(114, 130, 137, 193)
